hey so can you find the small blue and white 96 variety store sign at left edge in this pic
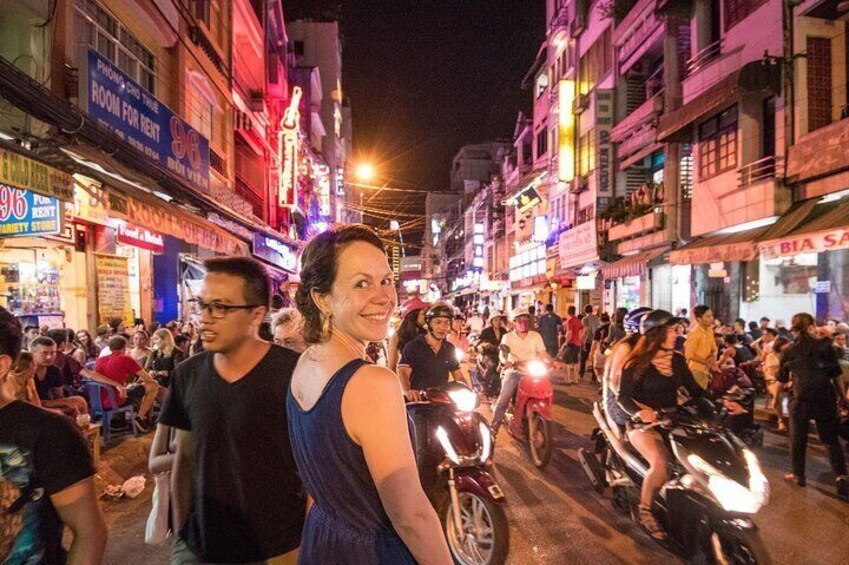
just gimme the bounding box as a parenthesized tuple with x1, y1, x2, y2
(0, 184, 62, 237)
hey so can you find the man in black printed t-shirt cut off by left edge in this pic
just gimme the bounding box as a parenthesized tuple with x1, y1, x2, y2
(0, 308, 107, 563)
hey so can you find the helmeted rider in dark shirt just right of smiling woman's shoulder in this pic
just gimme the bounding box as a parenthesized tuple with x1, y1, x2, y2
(398, 303, 471, 401)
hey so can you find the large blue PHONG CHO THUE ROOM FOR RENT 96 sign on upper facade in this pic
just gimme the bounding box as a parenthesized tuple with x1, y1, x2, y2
(81, 49, 209, 193)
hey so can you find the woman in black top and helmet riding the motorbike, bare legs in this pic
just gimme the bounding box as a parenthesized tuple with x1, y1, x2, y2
(619, 310, 742, 540)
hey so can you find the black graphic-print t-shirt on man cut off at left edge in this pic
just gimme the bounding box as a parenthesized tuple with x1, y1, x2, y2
(0, 401, 94, 563)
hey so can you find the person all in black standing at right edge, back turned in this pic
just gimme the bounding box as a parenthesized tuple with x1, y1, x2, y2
(776, 313, 849, 496)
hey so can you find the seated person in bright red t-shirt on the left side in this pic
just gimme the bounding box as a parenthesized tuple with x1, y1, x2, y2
(94, 335, 159, 433)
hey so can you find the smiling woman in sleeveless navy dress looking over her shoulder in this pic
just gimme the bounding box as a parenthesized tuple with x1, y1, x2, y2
(287, 225, 451, 565)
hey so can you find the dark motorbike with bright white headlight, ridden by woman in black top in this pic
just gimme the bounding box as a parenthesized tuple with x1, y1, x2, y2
(579, 399, 770, 564)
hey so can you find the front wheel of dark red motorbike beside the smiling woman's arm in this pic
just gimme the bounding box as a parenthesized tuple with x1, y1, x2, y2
(436, 486, 510, 565)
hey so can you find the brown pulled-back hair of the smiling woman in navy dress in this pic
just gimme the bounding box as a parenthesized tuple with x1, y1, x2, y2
(295, 224, 386, 343)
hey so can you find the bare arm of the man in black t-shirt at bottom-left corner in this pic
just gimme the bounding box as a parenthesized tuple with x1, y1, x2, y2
(50, 477, 107, 565)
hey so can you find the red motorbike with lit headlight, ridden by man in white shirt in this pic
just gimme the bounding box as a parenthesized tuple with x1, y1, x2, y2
(501, 344, 554, 469)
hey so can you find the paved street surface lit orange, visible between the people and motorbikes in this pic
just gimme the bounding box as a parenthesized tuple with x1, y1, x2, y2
(105, 376, 849, 565)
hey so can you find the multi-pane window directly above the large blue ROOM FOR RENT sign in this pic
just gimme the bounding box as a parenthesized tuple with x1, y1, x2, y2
(74, 0, 156, 94)
